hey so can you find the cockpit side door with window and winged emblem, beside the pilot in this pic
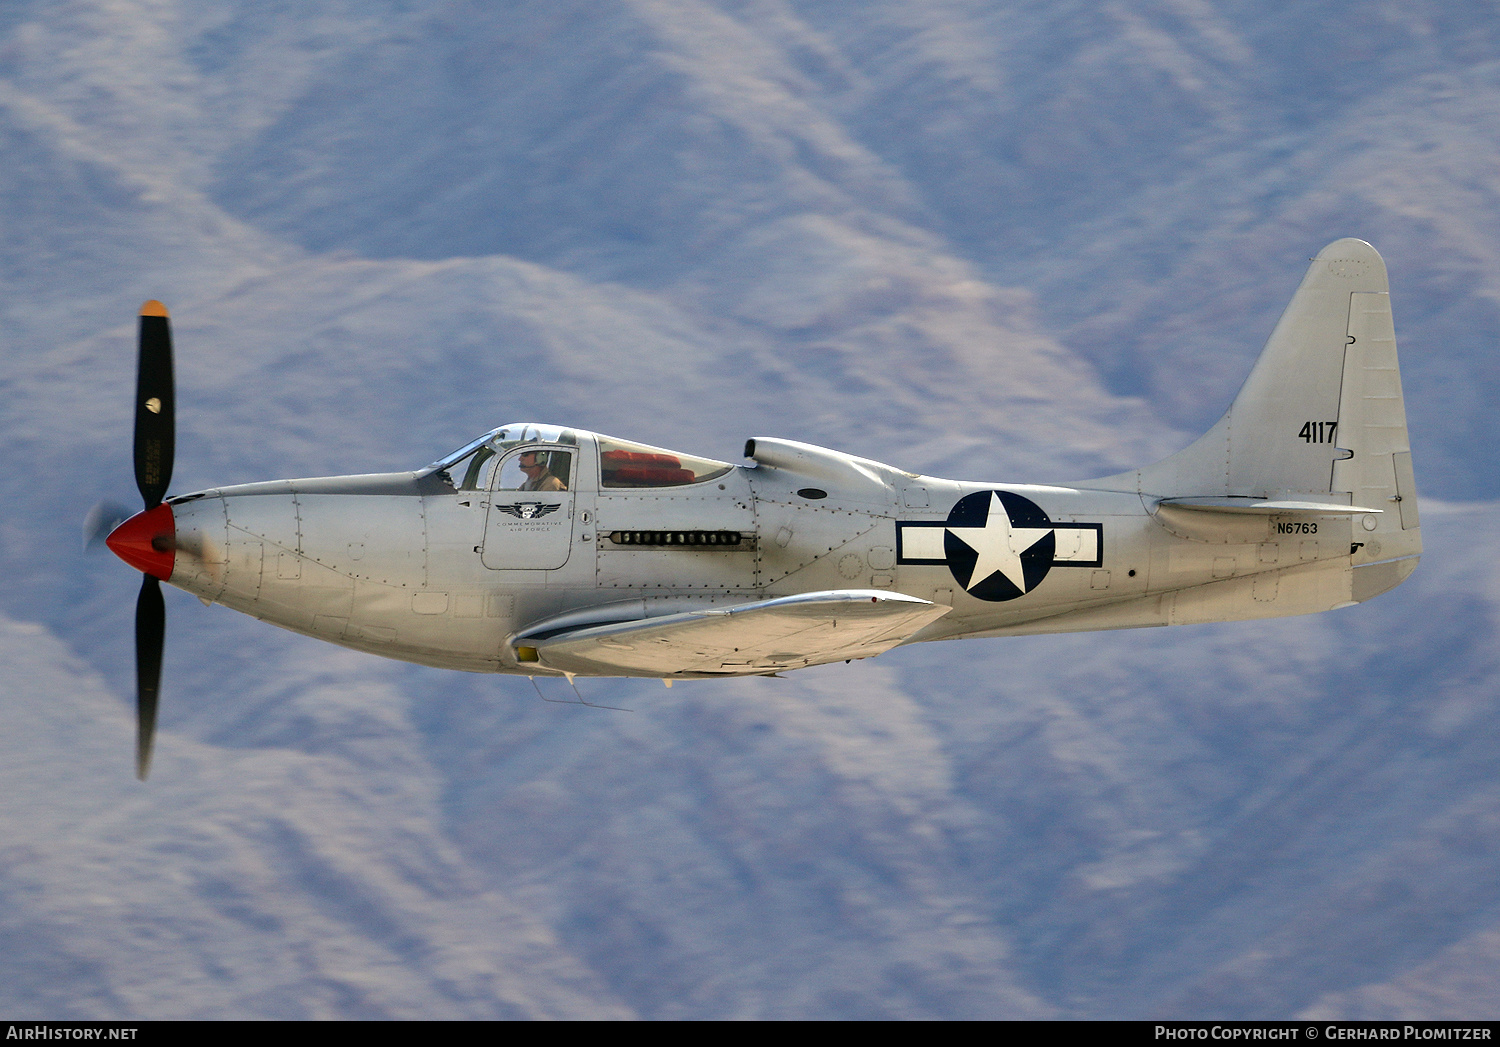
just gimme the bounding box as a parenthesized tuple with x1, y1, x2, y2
(480, 446, 578, 570)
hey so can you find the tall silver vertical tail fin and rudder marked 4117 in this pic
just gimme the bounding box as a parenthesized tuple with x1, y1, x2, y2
(1089, 240, 1422, 588)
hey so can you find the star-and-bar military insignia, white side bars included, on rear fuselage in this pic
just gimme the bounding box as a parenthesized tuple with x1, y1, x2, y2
(896, 491, 1104, 602)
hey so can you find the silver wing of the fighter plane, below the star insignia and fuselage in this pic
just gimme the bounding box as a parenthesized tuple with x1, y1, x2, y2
(516, 590, 951, 677)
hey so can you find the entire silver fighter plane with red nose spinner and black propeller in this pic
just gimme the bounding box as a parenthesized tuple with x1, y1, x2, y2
(107, 240, 1422, 777)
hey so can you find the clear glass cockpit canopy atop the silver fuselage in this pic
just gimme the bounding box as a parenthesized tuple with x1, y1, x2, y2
(426, 422, 734, 491)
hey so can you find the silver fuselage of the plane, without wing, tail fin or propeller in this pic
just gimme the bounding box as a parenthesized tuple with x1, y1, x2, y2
(126, 426, 1373, 675)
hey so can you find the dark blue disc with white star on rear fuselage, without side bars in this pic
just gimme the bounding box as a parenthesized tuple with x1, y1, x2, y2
(944, 491, 1058, 602)
